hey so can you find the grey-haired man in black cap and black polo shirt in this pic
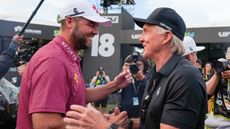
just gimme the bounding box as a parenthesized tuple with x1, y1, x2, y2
(134, 8, 207, 129)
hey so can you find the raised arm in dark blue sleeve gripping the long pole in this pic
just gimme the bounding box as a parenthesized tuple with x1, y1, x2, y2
(0, 34, 23, 79)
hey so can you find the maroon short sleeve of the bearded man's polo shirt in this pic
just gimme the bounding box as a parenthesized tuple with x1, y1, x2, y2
(29, 57, 70, 113)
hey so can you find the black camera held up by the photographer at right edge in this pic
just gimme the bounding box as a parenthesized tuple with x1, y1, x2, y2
(213, 58, 230, 74)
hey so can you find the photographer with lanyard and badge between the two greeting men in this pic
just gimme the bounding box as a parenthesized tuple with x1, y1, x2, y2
(119, 53, 149, 129)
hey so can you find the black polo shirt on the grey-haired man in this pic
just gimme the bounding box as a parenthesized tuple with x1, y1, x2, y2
(141, 54, 207, 129)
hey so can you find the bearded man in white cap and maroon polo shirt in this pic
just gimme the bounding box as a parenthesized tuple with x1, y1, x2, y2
(17, 0, 132, 129)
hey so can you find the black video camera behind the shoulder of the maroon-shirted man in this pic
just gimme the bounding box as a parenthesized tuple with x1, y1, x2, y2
(16, 39, 40, 66)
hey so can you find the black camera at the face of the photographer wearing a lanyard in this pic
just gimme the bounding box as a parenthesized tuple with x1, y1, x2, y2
(129, 52, 140, 74)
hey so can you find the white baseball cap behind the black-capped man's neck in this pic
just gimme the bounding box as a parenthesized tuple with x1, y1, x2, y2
(183, 36, 205, 56)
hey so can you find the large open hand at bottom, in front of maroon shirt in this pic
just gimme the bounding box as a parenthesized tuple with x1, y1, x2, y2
(64, 105, 111, 129)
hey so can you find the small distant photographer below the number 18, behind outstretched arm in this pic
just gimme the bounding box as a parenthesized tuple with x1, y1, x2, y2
(90, 67, 110, 113)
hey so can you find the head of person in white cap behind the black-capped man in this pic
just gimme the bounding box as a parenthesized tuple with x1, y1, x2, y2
(183, 36, 205, 66)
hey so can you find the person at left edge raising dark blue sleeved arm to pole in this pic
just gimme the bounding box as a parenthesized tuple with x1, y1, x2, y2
(0, 34, 23, 129)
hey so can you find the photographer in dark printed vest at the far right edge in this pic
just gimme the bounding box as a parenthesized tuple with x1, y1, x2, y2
(205, 47, 230, 129)
